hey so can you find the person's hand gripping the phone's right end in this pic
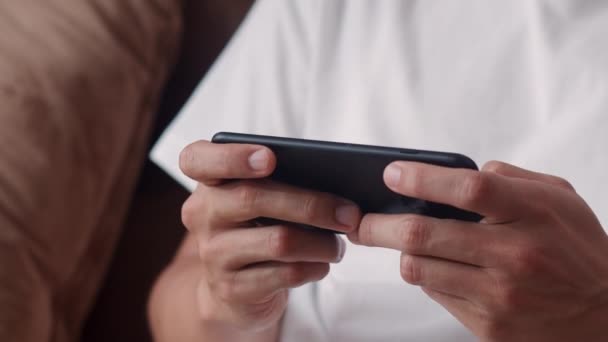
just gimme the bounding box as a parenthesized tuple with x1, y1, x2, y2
(349, 162, 608, 341)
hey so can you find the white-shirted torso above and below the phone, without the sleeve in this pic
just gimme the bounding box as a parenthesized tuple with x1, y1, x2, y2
(275, 0, 608, 341)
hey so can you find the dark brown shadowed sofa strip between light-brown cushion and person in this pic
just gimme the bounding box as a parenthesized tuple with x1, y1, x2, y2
(82, 0, 253, 342)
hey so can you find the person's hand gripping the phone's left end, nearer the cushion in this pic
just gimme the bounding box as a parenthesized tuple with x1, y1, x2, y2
(180, 141, 361, 332)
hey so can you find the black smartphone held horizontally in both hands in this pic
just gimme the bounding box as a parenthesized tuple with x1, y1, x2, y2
(212, 132, 482, 230)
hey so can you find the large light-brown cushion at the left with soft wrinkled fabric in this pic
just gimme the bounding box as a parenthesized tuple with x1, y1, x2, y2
(0, 0, 181, 342)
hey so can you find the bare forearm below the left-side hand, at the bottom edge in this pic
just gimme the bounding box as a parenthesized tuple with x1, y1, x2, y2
(148, 255, 279, 342)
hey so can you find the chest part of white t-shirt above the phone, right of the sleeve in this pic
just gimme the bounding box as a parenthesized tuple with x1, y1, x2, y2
(300, 1, 608, 225)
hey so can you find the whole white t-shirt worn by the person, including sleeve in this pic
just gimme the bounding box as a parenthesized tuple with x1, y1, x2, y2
(152, 0, 608, 341)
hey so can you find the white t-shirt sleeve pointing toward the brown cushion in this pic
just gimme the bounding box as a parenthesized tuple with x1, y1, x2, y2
(151, 0, 320, 190)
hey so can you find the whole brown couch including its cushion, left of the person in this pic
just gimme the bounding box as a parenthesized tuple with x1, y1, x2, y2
(0, 0, 251, 341)
